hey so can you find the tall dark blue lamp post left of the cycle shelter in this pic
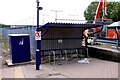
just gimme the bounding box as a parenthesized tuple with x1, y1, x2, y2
(35, 0, 42, 70)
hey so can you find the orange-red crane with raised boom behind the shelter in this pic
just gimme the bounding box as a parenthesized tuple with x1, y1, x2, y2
(94, 0, 120, 38)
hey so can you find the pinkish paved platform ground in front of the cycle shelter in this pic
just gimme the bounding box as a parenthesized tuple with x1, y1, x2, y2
(2, 58, 118, 78)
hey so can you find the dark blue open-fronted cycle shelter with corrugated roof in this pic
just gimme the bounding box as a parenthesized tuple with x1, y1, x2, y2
(36, 23, 102, 69)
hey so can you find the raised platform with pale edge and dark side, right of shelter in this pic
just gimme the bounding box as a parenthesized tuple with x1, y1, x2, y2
(88, 43, 120, 62)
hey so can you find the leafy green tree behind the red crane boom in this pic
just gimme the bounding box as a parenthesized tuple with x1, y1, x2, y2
(84, 2, 120, 23)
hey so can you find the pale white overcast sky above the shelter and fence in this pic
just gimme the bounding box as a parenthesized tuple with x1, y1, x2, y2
(0, 0, 120, 25)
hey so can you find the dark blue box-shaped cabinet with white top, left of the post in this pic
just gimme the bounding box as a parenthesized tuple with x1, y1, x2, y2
(9, 34, 31, 63)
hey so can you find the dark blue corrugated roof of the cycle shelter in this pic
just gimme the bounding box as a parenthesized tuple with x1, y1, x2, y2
(41, 22, 102, 28)
